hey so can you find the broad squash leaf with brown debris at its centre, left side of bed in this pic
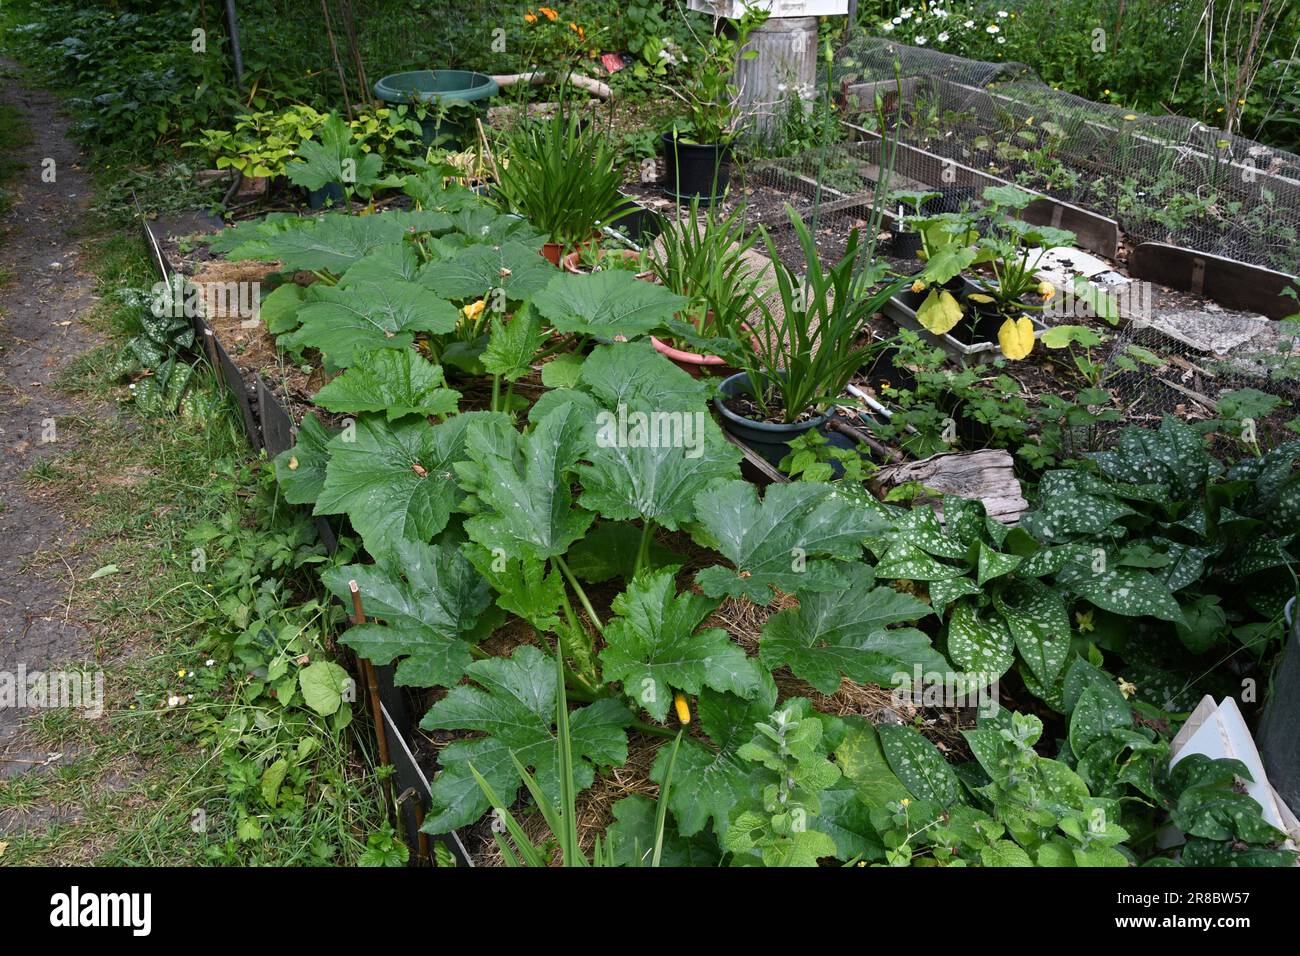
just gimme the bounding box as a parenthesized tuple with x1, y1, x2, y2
(313, 412, 495, 558)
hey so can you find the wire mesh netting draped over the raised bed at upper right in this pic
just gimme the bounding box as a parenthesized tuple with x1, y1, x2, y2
(831, 36, 1300, 274)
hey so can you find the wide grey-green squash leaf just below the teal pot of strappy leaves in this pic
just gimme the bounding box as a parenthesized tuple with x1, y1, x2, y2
(696, 481, 888, 605)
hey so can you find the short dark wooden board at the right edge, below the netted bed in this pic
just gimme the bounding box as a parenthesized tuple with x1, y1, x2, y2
(1128, 242, 1300, 319)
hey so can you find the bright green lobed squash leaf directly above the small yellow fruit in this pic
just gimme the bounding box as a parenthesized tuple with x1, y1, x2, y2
(601, 571, 762, 721)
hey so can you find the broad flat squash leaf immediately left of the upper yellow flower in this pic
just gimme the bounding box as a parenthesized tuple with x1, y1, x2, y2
(280, 282, 456, 365)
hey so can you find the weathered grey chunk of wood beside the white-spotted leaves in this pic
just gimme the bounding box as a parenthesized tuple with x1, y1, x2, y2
(868, 449, 1030, 524)
